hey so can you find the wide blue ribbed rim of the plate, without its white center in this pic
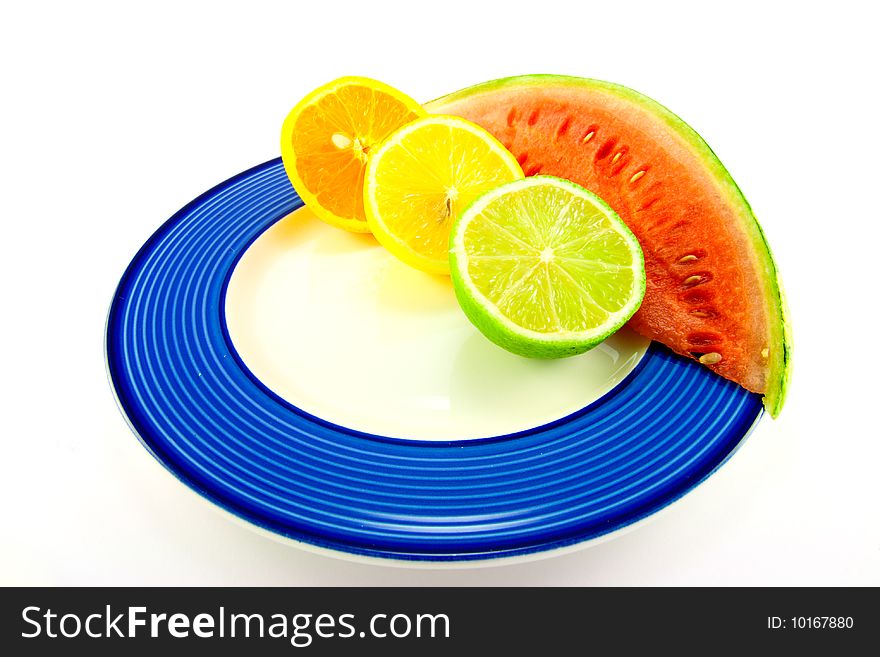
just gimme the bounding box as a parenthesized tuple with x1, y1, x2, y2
(106, 159, 763, 561)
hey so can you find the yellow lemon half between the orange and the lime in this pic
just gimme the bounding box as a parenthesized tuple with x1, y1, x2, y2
(364, 116, 523, 274)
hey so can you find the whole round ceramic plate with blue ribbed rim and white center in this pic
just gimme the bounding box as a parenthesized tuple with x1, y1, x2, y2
(106, 159, 762, 561)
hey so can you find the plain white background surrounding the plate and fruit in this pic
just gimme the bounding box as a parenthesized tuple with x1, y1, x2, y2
(0, 0, 880, 585)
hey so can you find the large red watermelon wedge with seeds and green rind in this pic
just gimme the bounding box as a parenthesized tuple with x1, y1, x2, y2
(427, 75, 790, 417)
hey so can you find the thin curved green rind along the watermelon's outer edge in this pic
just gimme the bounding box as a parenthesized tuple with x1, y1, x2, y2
(425, 74, 792, 417)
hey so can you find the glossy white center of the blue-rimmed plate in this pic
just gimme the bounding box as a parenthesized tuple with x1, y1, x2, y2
(226, 209, 648, 440)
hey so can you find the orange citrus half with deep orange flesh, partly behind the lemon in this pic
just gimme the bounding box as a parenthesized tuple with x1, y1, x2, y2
(281, 77, 425, 233)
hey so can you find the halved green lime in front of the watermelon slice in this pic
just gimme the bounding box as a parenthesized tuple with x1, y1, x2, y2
(449, 176, 645, 358)
